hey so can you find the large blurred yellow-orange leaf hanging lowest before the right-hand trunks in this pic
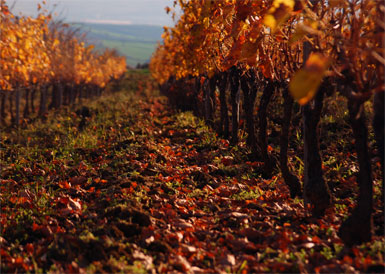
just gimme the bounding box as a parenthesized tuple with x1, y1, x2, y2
(289, 53, 330, 105)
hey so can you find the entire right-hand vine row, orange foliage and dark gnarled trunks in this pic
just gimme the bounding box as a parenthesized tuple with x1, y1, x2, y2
(150, 0, 385, 245)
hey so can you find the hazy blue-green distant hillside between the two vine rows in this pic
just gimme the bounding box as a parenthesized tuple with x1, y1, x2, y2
(72, 23, 163, 67)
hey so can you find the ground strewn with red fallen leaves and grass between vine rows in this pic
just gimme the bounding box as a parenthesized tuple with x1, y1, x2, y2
(0, 87, 384, 273)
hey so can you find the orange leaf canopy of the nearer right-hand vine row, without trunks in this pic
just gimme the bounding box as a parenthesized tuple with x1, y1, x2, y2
(151, 0, 384, 104)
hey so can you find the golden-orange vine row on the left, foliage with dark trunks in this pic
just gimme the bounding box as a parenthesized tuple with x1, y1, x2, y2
(0, 1, 126, 124)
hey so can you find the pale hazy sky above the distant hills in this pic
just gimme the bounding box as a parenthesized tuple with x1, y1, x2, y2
(6, 0, 173, 26)
